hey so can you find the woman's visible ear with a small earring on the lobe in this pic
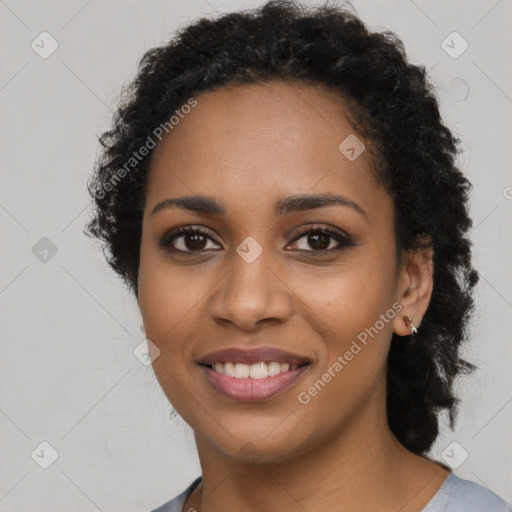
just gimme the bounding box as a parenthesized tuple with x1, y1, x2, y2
(393, 236, 434, 336)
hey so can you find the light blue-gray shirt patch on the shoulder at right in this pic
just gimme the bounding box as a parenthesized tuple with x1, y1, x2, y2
(422, 473, 512, 512)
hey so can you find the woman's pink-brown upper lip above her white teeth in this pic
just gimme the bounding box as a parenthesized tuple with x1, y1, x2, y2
(198, 347, 311, 365)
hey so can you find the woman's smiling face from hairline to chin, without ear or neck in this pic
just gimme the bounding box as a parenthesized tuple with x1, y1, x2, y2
(138, 82, 414, 461)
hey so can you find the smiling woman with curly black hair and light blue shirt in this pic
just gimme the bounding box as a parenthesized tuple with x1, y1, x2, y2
(87, 2, 507, 512)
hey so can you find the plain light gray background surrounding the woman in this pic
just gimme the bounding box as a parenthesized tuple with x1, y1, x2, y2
(0, 0, 512, 512)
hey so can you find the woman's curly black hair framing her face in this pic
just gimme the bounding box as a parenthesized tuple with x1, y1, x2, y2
(84, 0, 479, 455)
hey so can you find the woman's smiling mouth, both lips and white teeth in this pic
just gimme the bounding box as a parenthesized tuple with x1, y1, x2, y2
(198, 347, 312, 402)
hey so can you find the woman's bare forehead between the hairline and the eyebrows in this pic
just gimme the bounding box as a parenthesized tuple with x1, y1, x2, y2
(147, 81, 388, 220)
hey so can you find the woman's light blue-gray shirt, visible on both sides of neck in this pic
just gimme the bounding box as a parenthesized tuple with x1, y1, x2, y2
(151, 473, 512, 512)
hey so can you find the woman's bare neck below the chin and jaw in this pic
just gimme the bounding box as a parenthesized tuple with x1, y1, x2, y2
(184, 380, 448, 512)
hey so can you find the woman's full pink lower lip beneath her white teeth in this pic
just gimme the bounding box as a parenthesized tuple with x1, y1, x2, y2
(199, 364, 310, 402)
